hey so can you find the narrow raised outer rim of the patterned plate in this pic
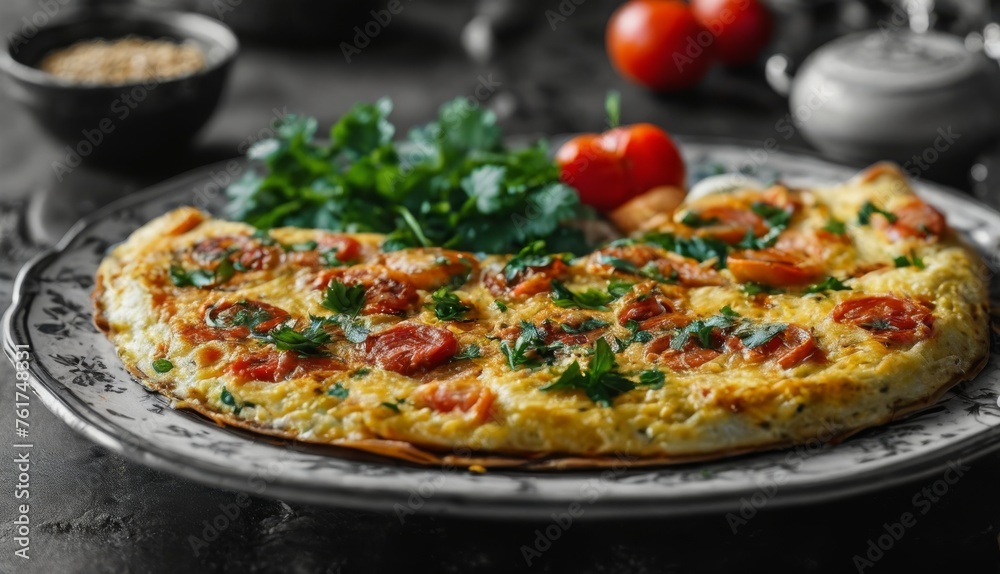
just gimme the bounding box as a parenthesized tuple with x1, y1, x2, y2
(3, 141, 1000, 520)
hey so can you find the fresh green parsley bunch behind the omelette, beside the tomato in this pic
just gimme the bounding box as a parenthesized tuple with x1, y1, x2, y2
(226, 98, 592, 253)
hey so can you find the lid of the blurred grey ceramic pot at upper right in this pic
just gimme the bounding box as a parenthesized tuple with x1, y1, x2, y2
(809, 30, 997, 92)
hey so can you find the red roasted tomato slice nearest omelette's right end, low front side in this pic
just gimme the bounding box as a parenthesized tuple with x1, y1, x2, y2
(832, 295, 934, 344)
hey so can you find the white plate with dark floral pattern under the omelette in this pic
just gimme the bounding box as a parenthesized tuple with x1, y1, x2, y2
(4, 140, 1000, 518)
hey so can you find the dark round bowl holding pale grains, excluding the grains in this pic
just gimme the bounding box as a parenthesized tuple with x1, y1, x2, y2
(0, 6, 239, 164)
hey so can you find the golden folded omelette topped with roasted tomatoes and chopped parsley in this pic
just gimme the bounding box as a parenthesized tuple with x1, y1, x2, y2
(94, 164, 989, 468)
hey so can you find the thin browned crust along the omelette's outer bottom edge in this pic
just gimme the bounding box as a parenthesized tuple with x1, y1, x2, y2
(91, 276, 992, 471)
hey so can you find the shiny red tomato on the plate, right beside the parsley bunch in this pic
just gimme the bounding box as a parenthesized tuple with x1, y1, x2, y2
(556, 124, 684, 213)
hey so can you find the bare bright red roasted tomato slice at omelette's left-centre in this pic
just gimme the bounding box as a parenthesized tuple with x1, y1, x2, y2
(364, 323, 458, 376)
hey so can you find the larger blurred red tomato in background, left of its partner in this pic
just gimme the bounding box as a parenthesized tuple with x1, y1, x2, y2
(606, 0, 714, 91)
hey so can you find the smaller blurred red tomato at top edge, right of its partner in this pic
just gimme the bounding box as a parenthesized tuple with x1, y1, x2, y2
(691, 0, 774, 66)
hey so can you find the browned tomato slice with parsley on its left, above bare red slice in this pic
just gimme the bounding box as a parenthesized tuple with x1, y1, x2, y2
(313, 265, 420, 315)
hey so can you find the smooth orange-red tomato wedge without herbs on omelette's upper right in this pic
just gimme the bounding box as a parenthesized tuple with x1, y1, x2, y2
(727, 247, 823, 287)
